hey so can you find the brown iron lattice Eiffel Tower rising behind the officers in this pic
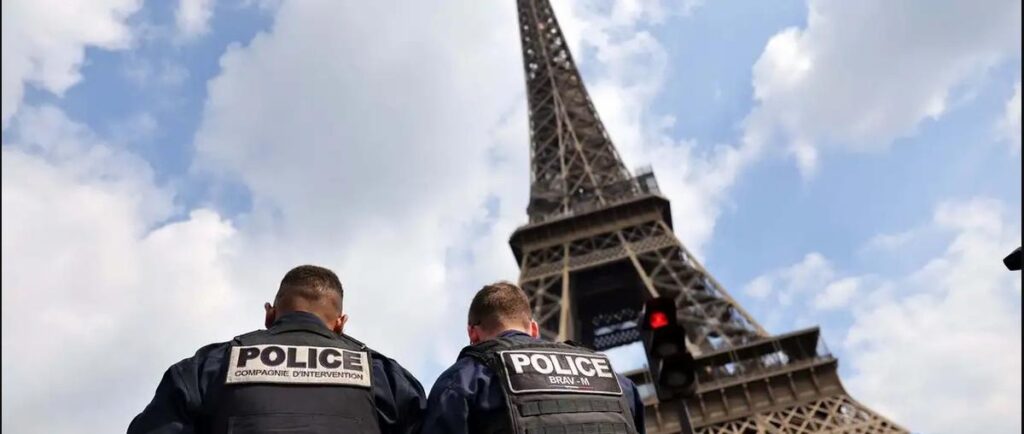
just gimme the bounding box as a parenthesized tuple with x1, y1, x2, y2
(509, 0, 907, 434)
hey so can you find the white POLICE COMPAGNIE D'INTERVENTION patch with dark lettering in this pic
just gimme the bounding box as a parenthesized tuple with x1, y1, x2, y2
(224, 345, 370, 387)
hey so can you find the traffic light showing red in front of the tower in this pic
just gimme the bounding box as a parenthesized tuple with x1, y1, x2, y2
(640, 297, 695, 400)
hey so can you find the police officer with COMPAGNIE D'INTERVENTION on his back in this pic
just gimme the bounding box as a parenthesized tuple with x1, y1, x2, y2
(128, 265, 426, 434)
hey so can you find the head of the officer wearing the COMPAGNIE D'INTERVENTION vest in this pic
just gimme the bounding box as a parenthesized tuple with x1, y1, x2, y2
(263, 265, 348, 333)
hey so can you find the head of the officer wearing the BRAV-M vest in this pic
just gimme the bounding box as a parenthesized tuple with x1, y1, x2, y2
(467, 281, 540, 344)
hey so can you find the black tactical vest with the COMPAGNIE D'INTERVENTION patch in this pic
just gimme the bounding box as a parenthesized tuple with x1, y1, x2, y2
(211, 323, 381, 434)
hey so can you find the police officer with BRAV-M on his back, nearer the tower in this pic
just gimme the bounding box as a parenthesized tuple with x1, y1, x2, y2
(421, 281, 644, 434)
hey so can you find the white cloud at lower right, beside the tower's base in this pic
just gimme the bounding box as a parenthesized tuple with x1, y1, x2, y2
(748, 199, 1021, 434)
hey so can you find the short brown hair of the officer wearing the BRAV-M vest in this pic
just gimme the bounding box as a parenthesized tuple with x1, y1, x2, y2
(469, 281, 532, 331)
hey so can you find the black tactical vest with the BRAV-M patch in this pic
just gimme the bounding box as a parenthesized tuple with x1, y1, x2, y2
(459, 338, 637, 434)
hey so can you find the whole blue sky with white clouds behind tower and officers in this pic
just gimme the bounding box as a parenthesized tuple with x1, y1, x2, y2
(0, 0, 1022, 433)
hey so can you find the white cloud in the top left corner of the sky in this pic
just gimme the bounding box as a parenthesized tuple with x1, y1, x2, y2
(0, 0, 141, 129)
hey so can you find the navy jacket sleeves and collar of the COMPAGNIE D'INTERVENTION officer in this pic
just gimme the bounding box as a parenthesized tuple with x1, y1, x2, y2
(128, 312, 426, 434)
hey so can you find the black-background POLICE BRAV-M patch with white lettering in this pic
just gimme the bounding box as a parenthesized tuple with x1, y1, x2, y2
(499, 350, 623, 395)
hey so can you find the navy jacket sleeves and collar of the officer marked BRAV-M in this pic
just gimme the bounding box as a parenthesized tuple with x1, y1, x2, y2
(420, 331, 645, 434)
